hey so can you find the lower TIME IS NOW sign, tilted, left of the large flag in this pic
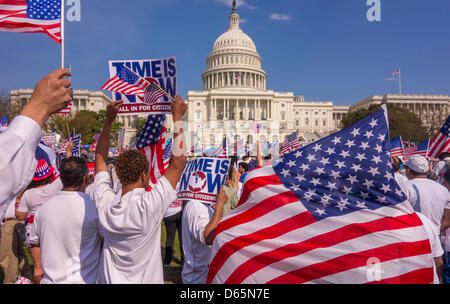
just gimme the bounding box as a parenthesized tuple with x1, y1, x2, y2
(178, 157, 230, 205)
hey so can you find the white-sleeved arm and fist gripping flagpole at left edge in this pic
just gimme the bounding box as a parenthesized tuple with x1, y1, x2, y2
(0, 69, 71, 214)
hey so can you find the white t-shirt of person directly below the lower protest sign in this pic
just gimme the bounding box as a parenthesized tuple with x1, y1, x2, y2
(181, 201, 214, 284)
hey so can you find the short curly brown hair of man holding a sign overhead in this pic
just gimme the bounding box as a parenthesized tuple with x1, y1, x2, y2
(115, 150, 149, 186)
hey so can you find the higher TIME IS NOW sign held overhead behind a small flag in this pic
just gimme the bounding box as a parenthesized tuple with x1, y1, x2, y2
(109, 57, 177, 115)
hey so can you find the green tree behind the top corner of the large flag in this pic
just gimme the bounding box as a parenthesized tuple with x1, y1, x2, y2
(342, 104, 428, 143)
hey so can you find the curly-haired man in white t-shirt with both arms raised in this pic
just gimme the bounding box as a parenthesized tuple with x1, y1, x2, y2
(94, 96, 187, 284)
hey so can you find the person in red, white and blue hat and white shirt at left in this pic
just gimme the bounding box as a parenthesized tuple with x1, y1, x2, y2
(16, 159, 63, 247)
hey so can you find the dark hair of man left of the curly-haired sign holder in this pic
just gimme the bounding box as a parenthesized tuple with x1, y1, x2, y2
(59, 156, 89, 188)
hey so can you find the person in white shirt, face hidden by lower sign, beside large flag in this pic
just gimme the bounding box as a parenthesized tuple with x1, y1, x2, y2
(181, 187, 228, 284)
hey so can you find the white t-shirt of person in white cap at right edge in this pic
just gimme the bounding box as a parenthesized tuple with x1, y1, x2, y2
(411, 178, 450, 233)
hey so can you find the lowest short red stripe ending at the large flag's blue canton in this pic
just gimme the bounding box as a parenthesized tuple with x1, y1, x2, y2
(207, 208, 316, 283)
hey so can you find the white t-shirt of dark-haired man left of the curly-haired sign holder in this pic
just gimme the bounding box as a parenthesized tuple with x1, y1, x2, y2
(30, 191, 102, 284)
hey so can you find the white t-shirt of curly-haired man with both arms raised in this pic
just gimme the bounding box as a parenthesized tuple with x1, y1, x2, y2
(94, 171, 177, 284)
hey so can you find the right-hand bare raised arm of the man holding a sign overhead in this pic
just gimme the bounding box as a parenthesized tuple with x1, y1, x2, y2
(164, 95, 187, 189)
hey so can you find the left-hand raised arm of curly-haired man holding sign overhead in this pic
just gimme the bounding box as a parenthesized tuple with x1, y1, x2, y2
(95, 100, 123, 174)
